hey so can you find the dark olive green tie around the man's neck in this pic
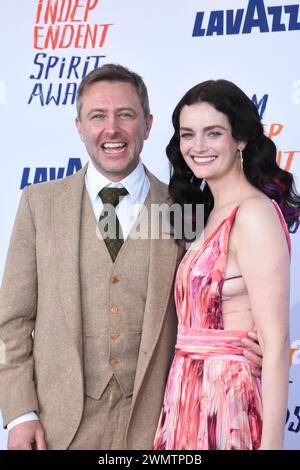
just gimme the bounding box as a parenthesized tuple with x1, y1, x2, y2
(99, 188, 128, 262)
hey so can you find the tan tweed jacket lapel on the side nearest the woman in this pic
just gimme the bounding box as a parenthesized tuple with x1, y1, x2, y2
(133, 172, 178, 402)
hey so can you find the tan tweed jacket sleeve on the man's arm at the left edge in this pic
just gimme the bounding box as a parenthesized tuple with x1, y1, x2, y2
(0, 187, 39, 426)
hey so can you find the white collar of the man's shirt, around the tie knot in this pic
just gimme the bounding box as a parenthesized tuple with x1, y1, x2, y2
(85, 160, 146, 203)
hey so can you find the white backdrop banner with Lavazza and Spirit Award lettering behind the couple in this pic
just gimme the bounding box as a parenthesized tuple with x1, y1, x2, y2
(0, 0, 300, 449)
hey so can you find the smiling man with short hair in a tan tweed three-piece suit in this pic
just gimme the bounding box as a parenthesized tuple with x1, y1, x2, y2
(0, 64, 260, 449)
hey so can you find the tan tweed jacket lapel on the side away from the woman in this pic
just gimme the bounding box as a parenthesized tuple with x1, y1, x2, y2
(52, 165, 87, 353)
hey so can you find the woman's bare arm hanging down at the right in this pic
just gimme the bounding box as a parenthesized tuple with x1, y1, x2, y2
(234, 199, 290, 449)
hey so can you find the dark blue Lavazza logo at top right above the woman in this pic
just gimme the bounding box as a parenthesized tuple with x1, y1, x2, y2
(193, 0, 300, 37)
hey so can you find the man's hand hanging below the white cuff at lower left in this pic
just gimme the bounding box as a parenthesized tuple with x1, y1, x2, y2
(8, 421, 47, 450)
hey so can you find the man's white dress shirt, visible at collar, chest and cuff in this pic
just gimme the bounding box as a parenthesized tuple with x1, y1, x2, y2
(7, 161, 150, 431)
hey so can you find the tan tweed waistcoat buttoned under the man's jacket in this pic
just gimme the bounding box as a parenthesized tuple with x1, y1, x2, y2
(80, 189, 150, 399)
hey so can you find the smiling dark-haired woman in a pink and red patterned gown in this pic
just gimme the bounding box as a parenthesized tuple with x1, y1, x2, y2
(154, 80, 300, 450)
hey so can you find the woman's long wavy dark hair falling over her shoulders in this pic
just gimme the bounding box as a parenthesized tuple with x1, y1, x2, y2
(166, 80, 300, 237)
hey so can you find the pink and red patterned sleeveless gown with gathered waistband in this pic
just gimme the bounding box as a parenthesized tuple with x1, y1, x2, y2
(153, 201, 289, 450)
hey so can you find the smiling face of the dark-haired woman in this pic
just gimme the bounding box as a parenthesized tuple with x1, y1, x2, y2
(179, 102, 245, 181)
